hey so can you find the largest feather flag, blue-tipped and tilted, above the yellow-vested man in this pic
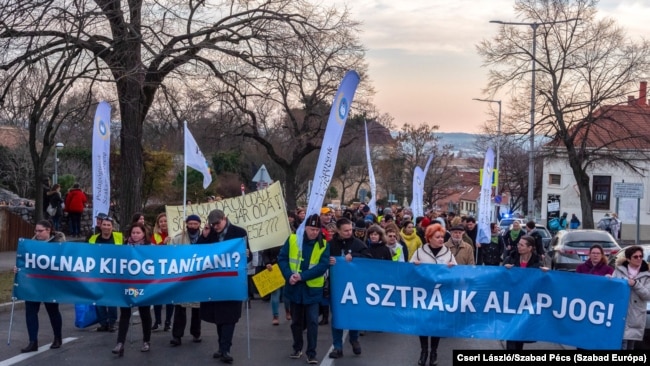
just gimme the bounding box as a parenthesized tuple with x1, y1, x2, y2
(296, 70, 361, 258)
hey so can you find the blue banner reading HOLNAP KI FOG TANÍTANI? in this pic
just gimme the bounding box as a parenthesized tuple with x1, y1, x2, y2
(14, 238, 248, 307)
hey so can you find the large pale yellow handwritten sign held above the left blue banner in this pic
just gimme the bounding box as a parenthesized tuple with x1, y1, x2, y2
(165, 182, 291, 252)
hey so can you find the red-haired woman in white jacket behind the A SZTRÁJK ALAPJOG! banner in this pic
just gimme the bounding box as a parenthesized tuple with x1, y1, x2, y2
(411, 224, 457, 366)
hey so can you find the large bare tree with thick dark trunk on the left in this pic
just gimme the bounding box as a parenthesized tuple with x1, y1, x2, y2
(0, 0, 364, 222)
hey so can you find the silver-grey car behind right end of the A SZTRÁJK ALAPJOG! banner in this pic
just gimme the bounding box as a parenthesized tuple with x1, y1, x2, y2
(549, 229, 621, 271)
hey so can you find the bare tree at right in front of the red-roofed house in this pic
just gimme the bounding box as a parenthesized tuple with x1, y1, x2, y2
(477, 0, 650, 228)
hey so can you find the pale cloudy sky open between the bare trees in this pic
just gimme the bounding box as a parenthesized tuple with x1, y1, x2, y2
(334, 0, 650, 133)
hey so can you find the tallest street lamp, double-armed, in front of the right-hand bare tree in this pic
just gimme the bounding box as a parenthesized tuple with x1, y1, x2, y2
(490, 18, 580, 220)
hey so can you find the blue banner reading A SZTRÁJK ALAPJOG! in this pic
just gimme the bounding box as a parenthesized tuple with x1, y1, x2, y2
(330, 258, 630, 349)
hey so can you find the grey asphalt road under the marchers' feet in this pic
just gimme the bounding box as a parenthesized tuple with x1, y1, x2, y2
(0, 300, 562, 366)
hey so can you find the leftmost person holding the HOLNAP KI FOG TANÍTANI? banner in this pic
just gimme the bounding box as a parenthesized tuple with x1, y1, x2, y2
(14, 220, 65, 353)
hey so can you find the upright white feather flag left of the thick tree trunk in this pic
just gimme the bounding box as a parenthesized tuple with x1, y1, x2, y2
(92, 101, 111, 217)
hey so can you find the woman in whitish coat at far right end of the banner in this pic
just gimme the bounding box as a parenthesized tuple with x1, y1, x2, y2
(613, 245, 650, 350)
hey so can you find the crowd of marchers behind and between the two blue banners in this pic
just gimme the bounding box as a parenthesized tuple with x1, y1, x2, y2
(16, 204, 650, 365)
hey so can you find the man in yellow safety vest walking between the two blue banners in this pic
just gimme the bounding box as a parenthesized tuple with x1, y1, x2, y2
(278, 214, 330, 364)
